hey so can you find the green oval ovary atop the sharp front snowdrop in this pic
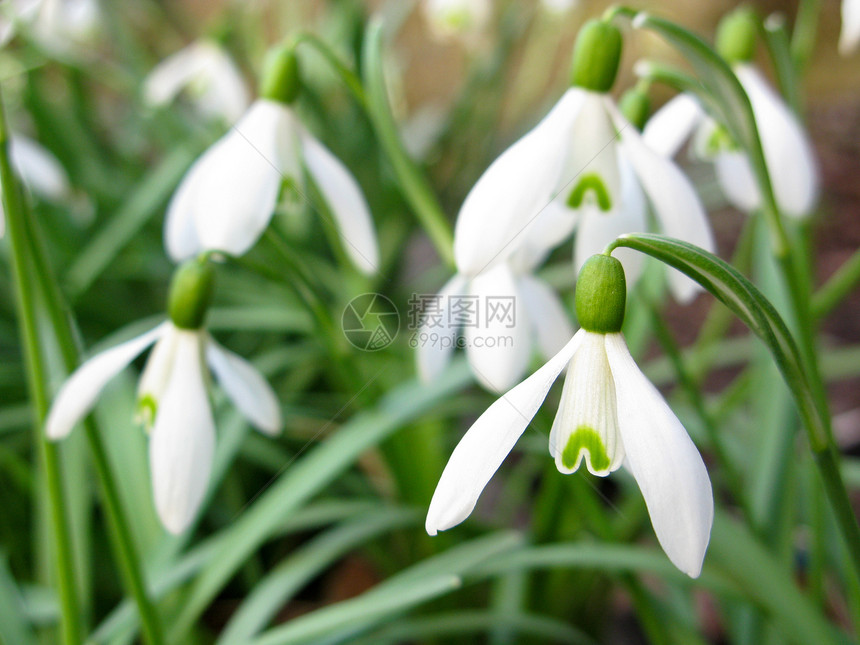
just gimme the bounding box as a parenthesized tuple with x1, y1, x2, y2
(576, 255, 627, 334)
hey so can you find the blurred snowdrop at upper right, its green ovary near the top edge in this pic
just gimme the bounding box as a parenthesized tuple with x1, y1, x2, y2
(644, 10, 818, 217)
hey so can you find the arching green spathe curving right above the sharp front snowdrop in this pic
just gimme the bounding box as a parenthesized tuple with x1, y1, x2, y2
(611, 233, 830, 452)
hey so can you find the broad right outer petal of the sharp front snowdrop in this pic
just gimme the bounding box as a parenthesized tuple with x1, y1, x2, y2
(606, 334, 714, 578)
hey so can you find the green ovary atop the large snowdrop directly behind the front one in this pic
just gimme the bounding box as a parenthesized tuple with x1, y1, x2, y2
(570, 20, 622, 92)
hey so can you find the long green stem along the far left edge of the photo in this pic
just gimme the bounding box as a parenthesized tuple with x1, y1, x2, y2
(0, 87, 82, 645)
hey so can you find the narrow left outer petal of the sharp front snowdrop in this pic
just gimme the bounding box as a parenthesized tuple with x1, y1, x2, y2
(425, 331, 583, 535)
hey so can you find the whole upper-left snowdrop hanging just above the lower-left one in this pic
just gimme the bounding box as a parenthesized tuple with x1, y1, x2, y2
(165, 49, 379, 273)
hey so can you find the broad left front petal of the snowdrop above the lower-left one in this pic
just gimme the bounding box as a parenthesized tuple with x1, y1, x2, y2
(182, 100, 298, 255)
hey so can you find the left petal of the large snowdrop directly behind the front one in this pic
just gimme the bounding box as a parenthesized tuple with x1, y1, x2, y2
(454, 88, 585, 276)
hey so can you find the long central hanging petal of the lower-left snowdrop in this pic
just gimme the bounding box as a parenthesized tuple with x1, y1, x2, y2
(149, 330, 215, 534)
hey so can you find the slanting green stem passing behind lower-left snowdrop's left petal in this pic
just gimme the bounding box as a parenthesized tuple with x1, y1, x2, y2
(8, 97, 164, 645)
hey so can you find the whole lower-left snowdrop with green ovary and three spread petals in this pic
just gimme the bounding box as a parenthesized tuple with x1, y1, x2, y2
(45, 259, 282, 534)
